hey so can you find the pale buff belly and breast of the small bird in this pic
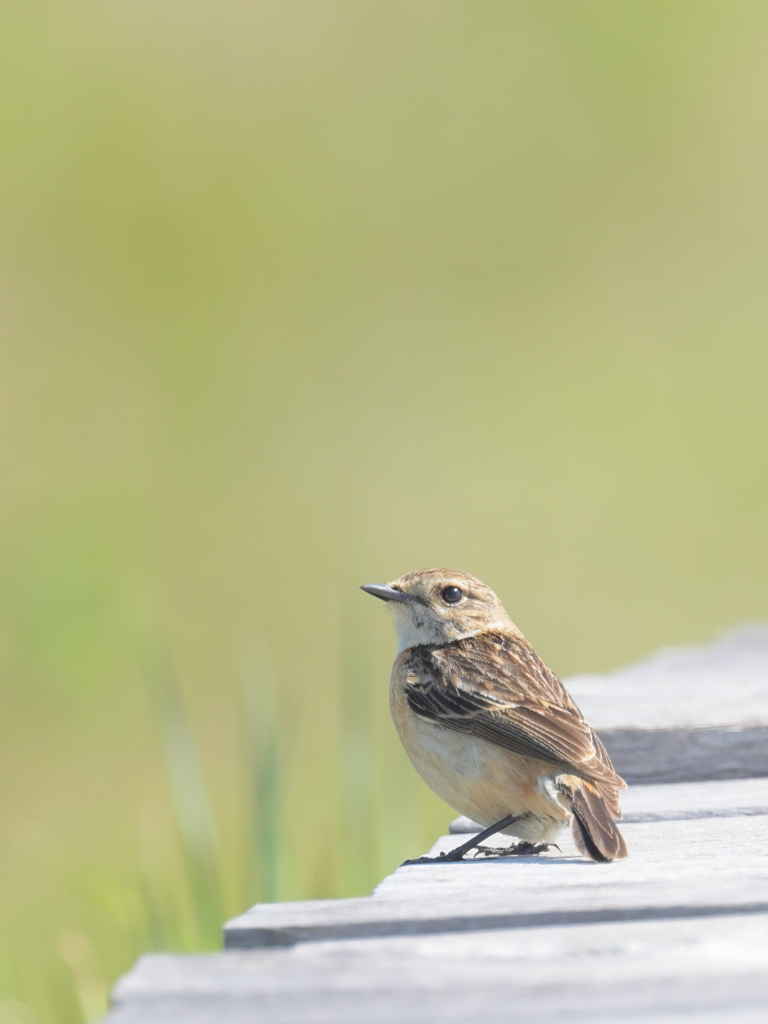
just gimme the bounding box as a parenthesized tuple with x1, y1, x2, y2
(390, 680, 570, 843)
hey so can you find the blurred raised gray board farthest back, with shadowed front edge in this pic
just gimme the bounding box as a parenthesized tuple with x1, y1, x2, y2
(565, 625, 768, 782)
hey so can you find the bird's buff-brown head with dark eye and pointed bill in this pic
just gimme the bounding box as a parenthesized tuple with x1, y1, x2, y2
(360, 569, 515, 650)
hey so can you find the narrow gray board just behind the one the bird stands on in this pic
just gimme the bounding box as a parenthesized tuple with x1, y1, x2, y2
(451, 778, 768, 834)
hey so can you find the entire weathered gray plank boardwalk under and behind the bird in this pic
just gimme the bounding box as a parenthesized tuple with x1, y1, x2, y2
(102, 627, 768, 1024)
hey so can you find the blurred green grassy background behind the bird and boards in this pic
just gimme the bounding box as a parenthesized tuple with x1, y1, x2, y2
(0, 0, 768, 1024)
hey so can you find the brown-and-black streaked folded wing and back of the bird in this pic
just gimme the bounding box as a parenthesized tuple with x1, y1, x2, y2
(403, 631, 625, 788)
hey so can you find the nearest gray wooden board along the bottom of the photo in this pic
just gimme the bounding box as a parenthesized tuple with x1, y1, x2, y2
(110, 913, 768, 1024)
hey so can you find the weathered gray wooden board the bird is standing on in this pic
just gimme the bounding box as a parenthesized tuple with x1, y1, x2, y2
(224, 816, 768, 948)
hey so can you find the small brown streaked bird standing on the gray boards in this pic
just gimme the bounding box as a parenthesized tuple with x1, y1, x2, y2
(361, 569, 627, 861)
